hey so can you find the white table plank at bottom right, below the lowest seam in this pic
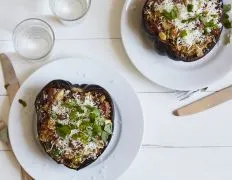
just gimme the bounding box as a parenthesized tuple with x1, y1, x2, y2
(119, 148, 232, 180)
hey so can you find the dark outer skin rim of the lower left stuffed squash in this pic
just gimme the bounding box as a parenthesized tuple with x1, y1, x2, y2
(34, 79, 114, 170)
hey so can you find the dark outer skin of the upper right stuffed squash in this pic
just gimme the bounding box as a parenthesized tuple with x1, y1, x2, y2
(142, 0, 223, 62)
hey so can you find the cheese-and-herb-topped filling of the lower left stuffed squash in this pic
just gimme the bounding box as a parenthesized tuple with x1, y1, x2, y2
(40, 89, 112, 168)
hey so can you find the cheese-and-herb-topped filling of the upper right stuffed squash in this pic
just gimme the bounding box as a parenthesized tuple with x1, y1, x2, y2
(145, 0, 222, 58)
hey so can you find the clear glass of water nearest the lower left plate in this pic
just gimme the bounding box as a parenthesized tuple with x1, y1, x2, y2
(13, 18, 55, 60)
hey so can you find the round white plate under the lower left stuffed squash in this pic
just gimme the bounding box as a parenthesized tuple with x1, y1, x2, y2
(9, 58, 144, 180)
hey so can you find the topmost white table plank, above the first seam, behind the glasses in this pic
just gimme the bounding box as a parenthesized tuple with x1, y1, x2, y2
(0, 0, 124, 40)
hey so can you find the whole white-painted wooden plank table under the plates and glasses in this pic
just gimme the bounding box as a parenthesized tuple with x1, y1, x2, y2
(0, 0, 232, 180)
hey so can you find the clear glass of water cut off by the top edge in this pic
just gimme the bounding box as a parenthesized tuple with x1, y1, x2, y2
(50, 0, 91, 24)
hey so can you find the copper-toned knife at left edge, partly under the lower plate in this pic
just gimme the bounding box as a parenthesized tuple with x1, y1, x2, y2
(0, 53, 32, 180)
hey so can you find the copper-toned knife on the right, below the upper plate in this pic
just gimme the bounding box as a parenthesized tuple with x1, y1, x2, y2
(173, 86, 232, 116)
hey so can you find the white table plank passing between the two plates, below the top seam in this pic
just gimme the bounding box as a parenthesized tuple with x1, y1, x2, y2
(0, 39, 170, 94)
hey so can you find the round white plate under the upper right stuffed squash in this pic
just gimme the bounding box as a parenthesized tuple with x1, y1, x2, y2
(121, 0, 232, 90)
